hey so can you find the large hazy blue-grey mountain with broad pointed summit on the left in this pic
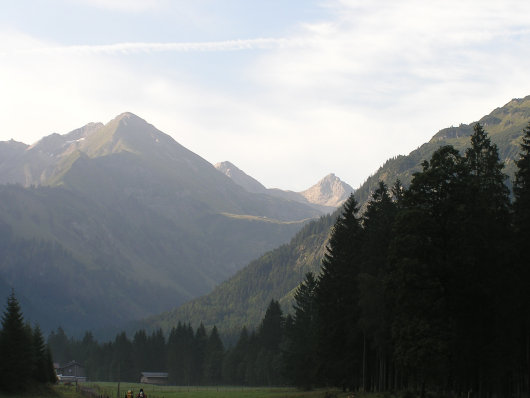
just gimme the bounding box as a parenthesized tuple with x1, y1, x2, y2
(0, 113, 321, 331)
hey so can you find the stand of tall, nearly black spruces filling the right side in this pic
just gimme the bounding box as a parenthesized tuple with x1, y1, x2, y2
(283, 124, 530, 397)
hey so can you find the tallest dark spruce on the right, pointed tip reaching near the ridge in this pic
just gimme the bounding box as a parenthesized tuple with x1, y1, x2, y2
(454, 123, 515, 392)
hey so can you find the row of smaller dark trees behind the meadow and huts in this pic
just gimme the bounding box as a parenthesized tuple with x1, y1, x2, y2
(48, 301, 286, 385)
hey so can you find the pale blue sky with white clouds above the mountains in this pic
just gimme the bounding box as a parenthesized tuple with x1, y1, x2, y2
(0, 0, 530, 191)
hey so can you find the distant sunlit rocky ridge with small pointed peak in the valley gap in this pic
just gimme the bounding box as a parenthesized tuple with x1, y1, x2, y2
(215, 162, 354, 213)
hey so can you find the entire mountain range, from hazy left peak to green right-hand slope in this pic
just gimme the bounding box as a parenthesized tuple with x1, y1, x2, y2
(0, 97, 530, 333)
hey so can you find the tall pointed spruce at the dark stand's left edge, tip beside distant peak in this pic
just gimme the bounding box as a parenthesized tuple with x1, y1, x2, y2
(316, 195, 362, 388)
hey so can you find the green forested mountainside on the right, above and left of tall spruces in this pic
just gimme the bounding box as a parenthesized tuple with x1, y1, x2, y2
(147, 96, 530, 334)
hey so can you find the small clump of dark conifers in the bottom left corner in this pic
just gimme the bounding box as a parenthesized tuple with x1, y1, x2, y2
(0, 292, 56, 393)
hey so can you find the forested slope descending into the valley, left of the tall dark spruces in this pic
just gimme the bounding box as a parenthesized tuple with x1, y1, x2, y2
(140, 215, 336, 334)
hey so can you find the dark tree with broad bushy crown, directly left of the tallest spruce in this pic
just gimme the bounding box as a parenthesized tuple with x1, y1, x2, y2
(385, 146, 465, 389)
